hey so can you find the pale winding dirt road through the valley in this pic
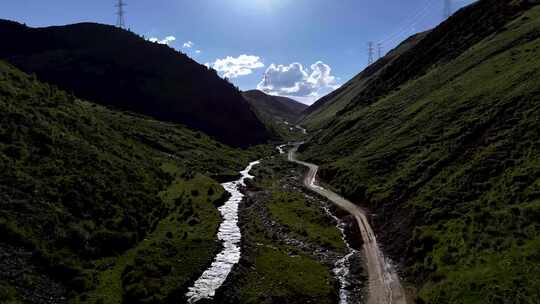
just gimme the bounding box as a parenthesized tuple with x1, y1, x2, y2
(289, 145, 407, 304)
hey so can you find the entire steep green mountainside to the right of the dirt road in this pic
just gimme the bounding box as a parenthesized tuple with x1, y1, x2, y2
(304, 0, 540, 303)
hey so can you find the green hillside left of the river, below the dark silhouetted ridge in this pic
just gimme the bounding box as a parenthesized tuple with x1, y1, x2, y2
(0, 62, 256, 303)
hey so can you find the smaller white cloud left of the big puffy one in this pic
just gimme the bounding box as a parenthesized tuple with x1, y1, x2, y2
(212, 55, 264, 78)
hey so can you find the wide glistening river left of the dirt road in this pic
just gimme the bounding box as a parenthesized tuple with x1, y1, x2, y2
(186, 161, 260, 303)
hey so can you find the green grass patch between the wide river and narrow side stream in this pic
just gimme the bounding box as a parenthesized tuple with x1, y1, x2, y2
(237, 209, 337, 303)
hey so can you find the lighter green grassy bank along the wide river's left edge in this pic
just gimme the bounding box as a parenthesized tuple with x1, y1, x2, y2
(82, 171, 225, 304)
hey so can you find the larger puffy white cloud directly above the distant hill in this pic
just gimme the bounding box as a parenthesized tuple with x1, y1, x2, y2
(257, 61, 339, 101)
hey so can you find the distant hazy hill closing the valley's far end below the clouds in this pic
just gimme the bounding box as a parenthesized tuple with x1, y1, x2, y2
(242, 90, 308, 140)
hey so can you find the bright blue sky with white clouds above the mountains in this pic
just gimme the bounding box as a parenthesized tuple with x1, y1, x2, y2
(0, 0, 473, 103)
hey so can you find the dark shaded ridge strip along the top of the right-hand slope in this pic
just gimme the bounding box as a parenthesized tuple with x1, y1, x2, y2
(303, 0, 535, 129)
